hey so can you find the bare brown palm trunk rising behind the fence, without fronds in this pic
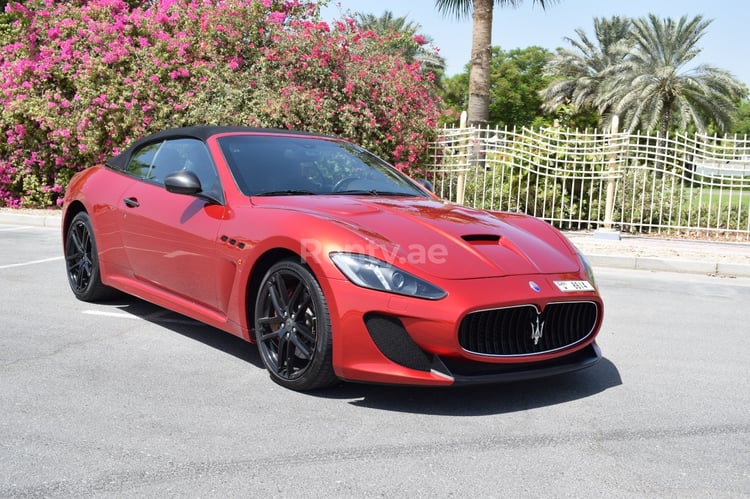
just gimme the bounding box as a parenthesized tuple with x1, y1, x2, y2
(468, 0, 494, 127)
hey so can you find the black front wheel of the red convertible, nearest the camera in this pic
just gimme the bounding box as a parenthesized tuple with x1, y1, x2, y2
(255, 260, 338, 391)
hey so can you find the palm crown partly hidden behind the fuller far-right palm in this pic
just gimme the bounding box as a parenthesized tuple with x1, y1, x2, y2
(541, 16, 632, 125)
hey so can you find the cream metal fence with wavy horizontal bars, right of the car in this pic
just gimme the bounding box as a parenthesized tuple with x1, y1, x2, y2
(428, 124, 750, 240)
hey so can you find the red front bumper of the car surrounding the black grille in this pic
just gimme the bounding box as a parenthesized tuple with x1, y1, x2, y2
(324, 274, 603, 386)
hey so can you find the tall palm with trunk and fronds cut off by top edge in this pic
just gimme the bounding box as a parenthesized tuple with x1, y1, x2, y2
(435, 0, 556, 126)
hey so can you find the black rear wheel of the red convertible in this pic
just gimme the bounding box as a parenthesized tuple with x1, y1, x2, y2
(65, 211, 115, 301)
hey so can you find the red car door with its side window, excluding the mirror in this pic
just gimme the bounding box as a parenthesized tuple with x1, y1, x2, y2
(120, 138, 225, 311)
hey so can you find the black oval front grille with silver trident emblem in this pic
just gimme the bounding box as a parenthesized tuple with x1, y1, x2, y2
(458, 302, 598, 356)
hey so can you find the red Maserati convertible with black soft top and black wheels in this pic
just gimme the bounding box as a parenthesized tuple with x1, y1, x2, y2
(62, 126, 603, 390)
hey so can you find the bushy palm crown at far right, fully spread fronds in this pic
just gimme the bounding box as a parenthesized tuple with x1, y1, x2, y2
(600, 14, 747, 136)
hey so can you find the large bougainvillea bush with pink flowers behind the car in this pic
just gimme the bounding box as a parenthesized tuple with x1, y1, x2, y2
(0, 0, 439, 207)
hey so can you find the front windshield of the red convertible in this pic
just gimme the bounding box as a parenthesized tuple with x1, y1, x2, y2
(218, 135, 427, 197)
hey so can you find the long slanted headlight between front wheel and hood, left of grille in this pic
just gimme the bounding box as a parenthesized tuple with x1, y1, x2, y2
(329, 253, 447, 300)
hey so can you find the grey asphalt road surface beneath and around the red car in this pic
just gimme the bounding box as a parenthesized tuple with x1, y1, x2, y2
(0, 225, 750, 498)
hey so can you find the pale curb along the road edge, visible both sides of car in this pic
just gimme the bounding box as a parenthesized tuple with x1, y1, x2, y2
(0, 209, 750, 277)
